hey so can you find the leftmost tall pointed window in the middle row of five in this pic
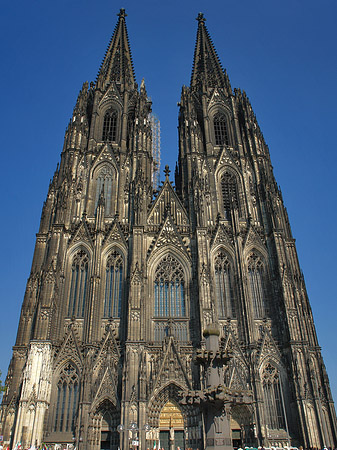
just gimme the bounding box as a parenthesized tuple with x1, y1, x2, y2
(68, 250, 89, 317)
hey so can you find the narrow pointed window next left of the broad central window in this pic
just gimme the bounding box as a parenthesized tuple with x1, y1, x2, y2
(103, 251, 123, 317)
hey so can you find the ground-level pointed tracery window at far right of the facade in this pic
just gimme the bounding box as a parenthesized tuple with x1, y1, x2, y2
(262, 363, 285, 429)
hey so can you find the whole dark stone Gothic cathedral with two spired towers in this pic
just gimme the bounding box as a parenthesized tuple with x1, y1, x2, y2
(0, 9, 337, 450)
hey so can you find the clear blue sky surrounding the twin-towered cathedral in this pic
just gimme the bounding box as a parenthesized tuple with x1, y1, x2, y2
(0, 0, 337, 399)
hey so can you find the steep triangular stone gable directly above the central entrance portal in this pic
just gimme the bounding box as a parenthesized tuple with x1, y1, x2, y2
(153, 336, 191, 390)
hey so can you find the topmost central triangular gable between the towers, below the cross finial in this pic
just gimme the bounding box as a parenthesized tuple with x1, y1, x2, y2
(147, 179, 189, 225)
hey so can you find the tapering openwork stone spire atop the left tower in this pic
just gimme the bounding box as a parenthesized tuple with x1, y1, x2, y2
(96, 9, 136, 89)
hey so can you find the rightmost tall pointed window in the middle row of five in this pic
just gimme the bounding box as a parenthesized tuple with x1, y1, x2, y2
(248, 253, 266, 319)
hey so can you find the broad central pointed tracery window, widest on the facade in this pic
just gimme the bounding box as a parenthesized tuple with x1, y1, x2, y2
(154, 255, 186, 317)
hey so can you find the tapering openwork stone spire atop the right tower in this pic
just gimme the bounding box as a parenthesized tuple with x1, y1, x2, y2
(191, 13, 230, 90)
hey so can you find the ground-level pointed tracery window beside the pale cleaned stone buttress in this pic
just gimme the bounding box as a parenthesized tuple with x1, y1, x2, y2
(54, 362, 79, 432)
